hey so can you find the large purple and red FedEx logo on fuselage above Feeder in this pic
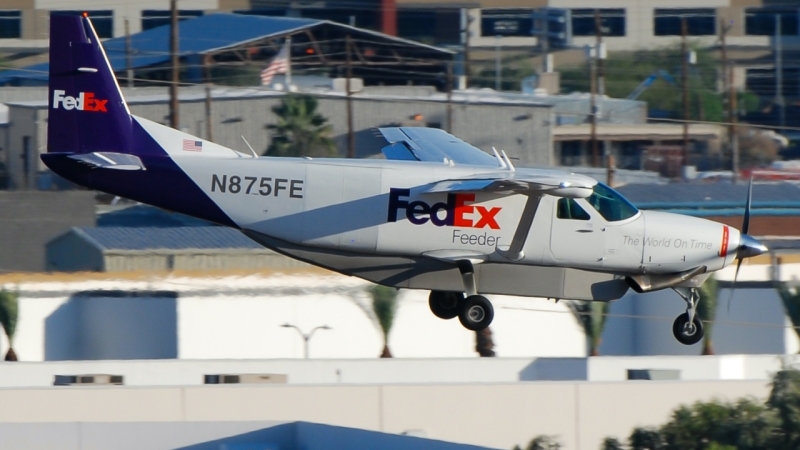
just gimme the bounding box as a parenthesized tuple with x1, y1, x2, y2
(388, 188, 502, 230)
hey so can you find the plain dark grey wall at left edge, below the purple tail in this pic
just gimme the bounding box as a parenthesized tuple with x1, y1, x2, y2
(0, 191, 95, 272)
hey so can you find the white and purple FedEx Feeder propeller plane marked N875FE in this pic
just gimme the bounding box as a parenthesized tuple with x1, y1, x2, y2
(42, 15, 766, 344)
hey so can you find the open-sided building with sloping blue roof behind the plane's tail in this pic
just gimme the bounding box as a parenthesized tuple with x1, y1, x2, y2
(0, 14, 453, 89)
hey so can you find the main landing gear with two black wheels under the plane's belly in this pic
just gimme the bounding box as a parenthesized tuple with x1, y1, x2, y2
(428, 260, 494, 331)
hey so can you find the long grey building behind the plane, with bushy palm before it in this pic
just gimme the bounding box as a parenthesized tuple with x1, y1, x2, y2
(4, 87, 568, 189)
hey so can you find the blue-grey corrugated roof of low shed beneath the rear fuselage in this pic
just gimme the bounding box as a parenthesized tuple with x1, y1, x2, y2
(73, 227, 263, 250)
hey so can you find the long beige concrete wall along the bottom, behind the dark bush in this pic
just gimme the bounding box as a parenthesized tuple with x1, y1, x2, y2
(0, 381, 769, 450)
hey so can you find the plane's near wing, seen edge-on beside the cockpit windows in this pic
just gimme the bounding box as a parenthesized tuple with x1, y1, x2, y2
(422, 169, 597, 198)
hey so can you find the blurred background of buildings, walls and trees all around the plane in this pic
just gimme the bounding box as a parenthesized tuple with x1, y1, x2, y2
(0, 0, 800, 449)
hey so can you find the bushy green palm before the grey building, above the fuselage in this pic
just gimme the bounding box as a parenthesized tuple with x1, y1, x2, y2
(265, 94, 336, 156)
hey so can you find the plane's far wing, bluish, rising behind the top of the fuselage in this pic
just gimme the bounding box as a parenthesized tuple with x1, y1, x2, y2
(378, 127, 497, 167)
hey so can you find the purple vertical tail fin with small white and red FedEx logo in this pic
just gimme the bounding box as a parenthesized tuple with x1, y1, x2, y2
(47, 14, 133, 153)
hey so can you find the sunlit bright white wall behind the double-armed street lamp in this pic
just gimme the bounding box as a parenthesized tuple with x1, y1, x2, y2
(0, 270, 586, 361)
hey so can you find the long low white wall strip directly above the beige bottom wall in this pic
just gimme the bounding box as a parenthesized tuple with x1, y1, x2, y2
(0, 356, 788, 388)
